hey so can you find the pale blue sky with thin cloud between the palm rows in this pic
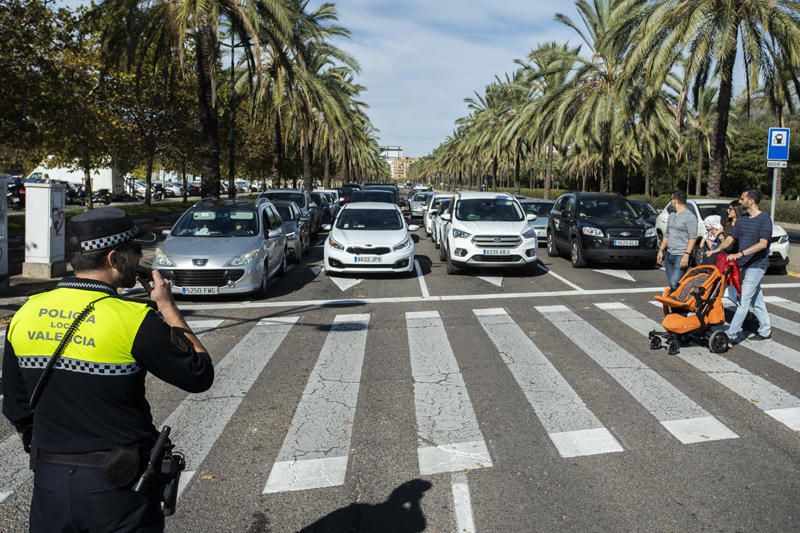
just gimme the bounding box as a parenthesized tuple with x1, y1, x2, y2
(322, 0, 579, 157)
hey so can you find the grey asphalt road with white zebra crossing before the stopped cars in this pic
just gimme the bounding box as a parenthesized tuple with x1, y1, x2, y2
(0, 222, 800, 532)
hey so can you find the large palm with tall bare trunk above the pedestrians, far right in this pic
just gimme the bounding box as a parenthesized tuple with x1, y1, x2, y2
(629, 0, 800, 197)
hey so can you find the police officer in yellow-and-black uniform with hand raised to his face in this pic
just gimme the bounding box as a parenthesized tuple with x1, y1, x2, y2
(2, 208, 214, 532)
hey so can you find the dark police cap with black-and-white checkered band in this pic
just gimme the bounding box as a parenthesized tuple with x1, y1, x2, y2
(67, 207, 156, 253)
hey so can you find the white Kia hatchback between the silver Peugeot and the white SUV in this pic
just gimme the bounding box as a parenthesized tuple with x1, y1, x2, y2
(323, 202, 419, 274)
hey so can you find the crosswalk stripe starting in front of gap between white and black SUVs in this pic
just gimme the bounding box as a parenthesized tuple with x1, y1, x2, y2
(536, 305, 738, 444)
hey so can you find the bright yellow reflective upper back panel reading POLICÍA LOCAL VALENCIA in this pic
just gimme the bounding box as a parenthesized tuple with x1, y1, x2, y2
(7, 287, 149, 375)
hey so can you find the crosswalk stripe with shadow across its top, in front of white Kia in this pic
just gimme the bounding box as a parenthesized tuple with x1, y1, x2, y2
(264, 314, 369, 494)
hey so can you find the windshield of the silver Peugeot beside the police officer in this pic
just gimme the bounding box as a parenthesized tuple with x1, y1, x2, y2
(172, 208, 258, 237)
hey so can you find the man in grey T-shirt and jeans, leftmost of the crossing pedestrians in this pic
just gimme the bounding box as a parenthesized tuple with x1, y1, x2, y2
(656, 191, 698, 289)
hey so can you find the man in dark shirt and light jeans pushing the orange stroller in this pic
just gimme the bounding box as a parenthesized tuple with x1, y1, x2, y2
(718, 189, 772, 344)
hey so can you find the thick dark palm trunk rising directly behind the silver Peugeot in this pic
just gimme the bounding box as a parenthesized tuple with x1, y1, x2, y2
(195, 20, 221, 198)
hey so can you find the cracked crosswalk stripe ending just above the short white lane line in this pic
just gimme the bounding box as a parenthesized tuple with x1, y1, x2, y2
(406, 311, 492, 475)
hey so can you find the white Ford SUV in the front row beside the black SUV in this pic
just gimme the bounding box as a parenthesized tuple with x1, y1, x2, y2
(440, 192, 538, 274)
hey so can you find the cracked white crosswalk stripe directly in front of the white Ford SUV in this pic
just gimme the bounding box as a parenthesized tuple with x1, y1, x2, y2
(473, 309, 624, 457)
